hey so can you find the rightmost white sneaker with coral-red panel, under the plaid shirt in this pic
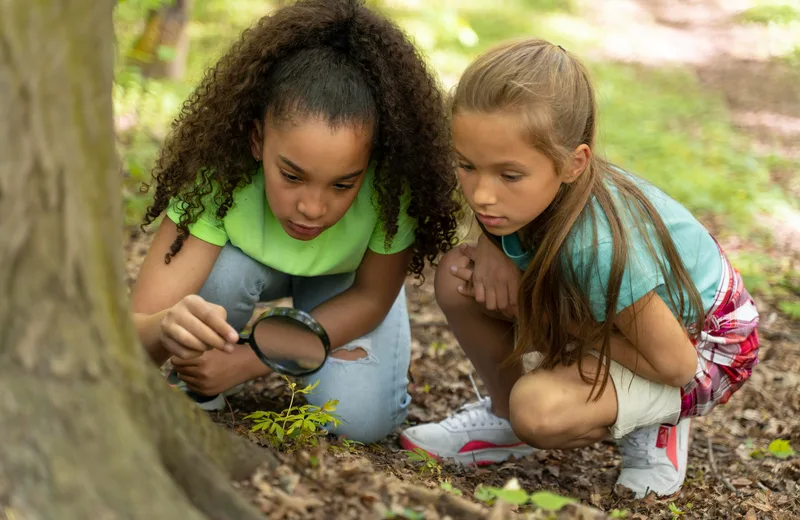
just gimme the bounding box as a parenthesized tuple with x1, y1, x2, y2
(617, 419, 691, 498)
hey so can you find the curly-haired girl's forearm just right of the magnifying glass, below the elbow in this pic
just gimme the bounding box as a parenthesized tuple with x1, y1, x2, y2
(311, 286, 400, 350)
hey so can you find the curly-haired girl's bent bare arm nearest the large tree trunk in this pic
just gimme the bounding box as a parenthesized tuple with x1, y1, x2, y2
(131, 218, 235, 365)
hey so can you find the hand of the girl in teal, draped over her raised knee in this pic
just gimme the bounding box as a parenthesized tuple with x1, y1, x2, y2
(451, 235, 521, 317)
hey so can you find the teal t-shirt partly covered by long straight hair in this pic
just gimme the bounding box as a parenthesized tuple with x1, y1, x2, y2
(501, 176, 723, 324)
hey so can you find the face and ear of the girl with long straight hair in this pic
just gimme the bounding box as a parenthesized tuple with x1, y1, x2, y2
(453, 111, 588, 236)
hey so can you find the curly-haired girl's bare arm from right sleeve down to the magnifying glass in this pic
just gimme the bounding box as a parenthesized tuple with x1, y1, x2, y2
(311, 248, 412, 349)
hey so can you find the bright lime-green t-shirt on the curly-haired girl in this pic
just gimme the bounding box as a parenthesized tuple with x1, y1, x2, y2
(167, 163, 416, 276)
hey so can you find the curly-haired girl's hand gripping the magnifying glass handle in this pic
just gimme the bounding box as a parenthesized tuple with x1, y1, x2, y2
(161, 294, 239, 359)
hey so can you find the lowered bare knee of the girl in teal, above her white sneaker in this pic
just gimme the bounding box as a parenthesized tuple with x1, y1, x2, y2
(509, 372, 568, 449)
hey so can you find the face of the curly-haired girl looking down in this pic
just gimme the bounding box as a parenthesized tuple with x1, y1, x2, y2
(251, 117, 373, 240)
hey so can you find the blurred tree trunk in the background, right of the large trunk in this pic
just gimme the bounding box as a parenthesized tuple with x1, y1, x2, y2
(130, 0, 191, 79)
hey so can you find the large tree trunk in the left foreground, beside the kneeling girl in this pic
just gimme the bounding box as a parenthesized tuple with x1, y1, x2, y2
(0, 0, 275, 520)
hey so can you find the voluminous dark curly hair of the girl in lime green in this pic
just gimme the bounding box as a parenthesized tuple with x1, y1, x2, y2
(144, 0, 461, 275)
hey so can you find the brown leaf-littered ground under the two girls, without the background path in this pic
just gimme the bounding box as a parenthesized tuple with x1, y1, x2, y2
(127, 228, 800, 520)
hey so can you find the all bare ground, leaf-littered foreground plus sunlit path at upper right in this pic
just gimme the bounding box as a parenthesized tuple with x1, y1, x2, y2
(126, 0, 800, 520)
